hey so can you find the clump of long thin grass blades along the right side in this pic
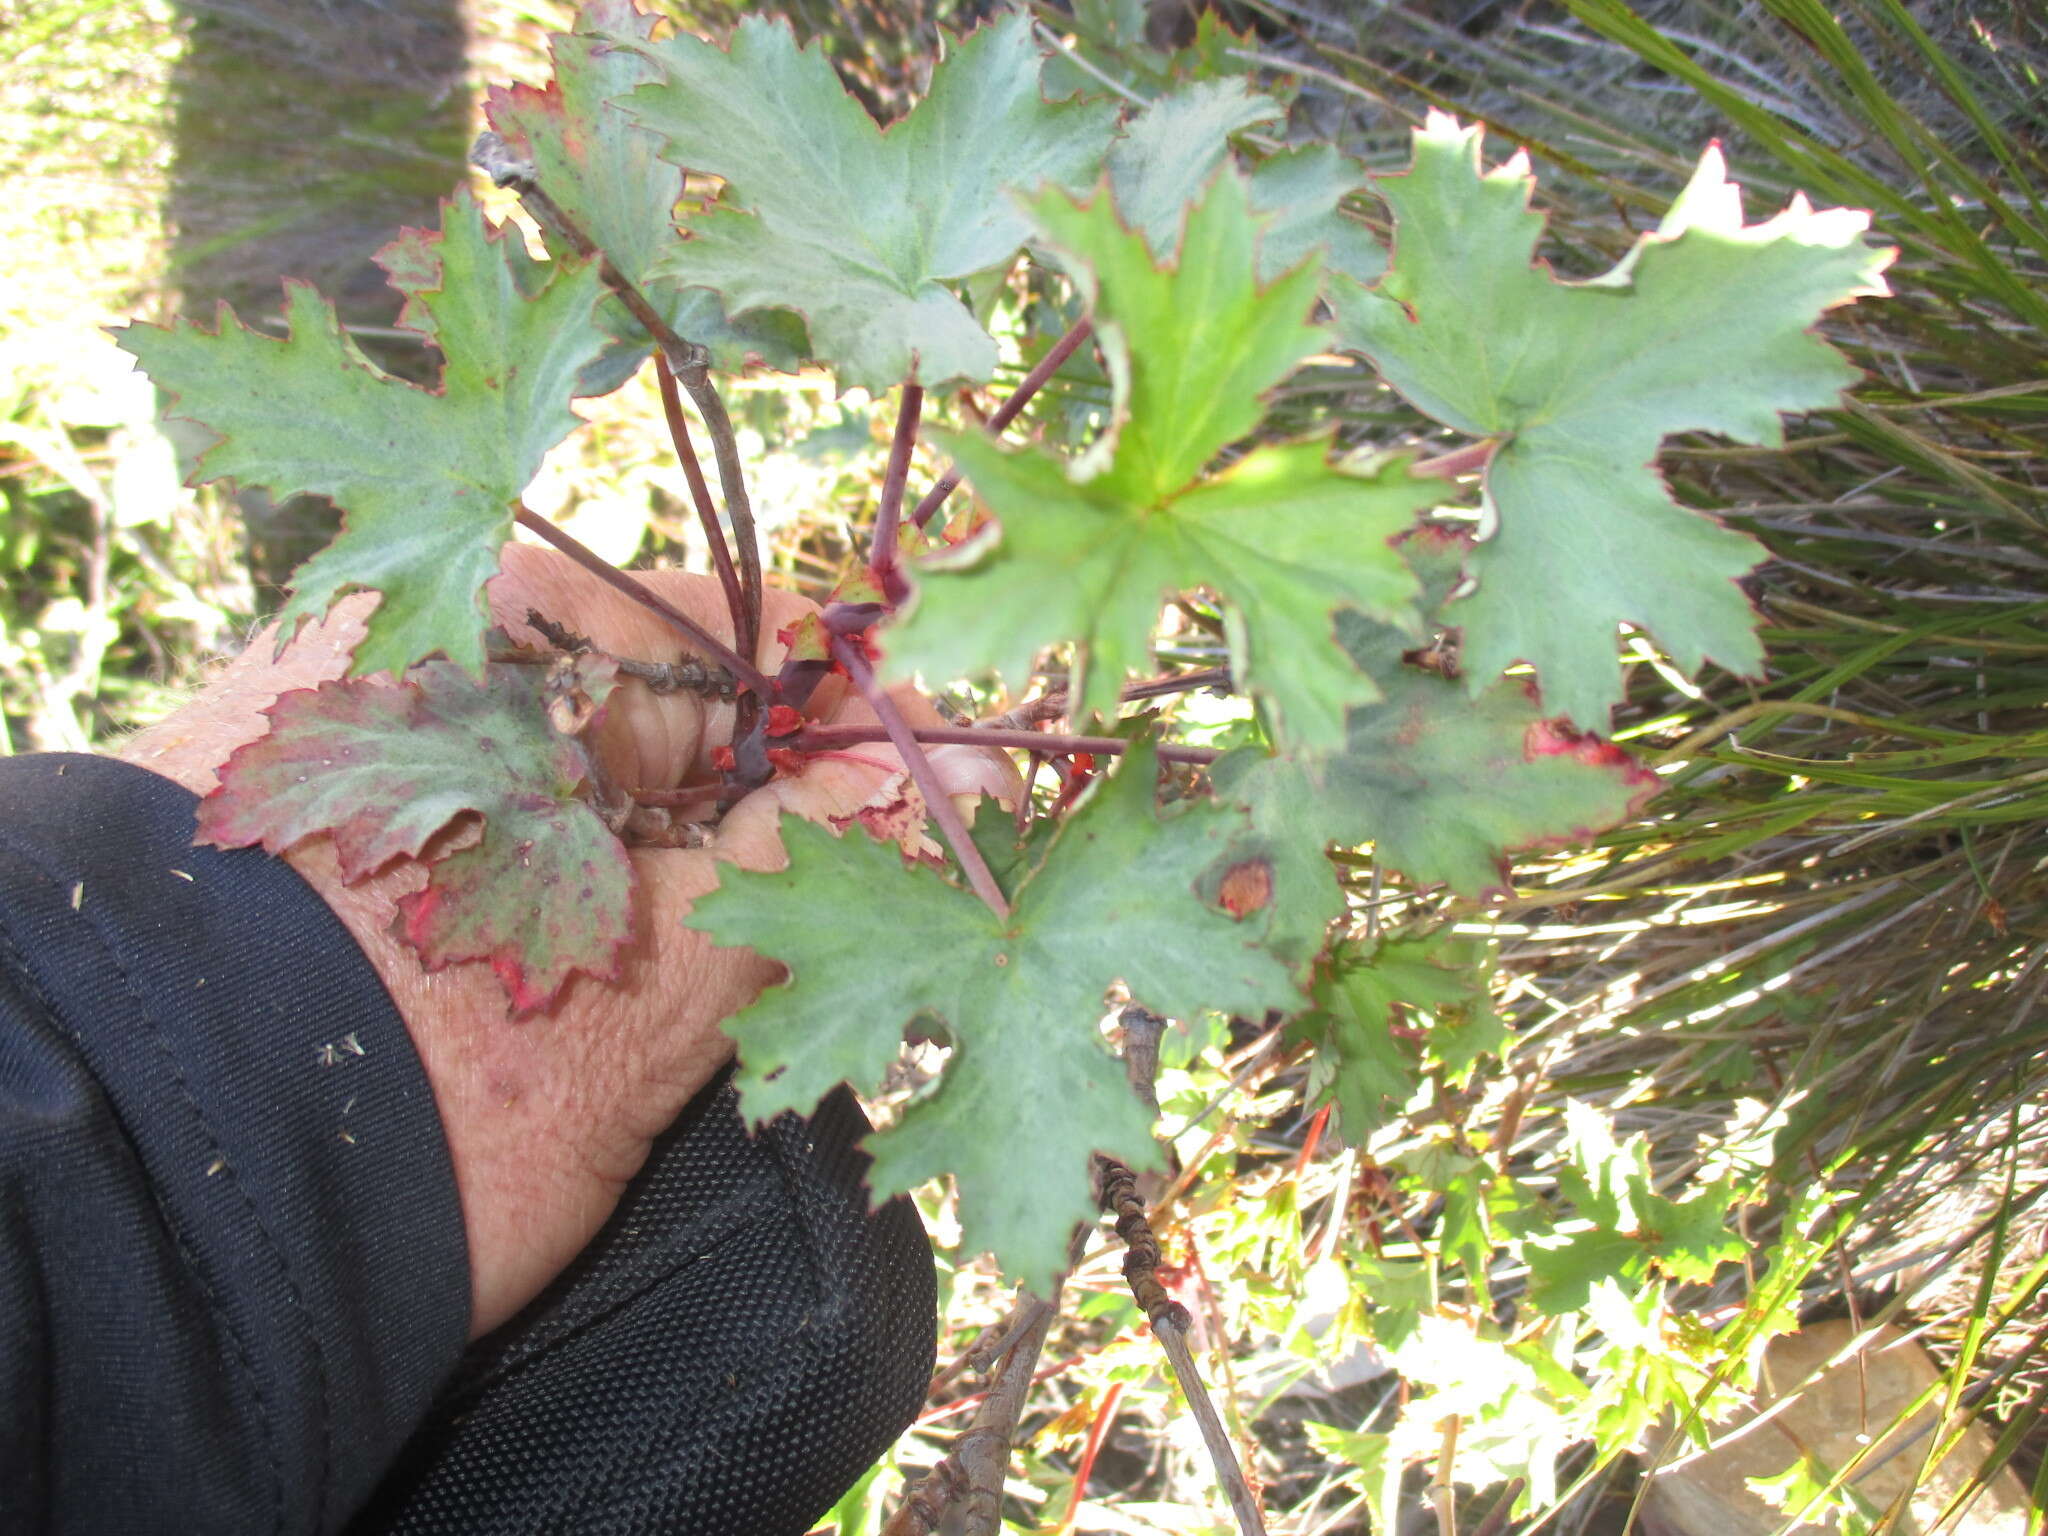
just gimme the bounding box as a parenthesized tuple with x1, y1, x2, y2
(1249, 0, 2048, 1520)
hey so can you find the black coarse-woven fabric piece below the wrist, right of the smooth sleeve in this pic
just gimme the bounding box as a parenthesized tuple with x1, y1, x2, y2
(350, 1081, 936, 1536)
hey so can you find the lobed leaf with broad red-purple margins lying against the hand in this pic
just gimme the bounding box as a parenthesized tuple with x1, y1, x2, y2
(199, 662, 633, 1014)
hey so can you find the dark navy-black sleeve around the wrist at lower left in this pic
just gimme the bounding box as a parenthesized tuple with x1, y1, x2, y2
(0, 754, 469, 1536)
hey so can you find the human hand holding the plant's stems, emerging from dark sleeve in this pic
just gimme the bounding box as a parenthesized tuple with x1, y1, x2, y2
(121, 545, 1018, 1337)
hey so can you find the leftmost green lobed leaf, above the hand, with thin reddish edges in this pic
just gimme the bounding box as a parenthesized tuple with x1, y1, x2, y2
(121, 193, 606, 676)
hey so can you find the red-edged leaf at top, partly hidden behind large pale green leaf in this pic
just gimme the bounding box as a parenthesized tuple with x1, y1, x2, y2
(483, 0, 805, 382)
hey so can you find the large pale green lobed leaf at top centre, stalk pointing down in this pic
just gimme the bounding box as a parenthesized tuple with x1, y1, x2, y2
(612, 14, 1116, 393)
